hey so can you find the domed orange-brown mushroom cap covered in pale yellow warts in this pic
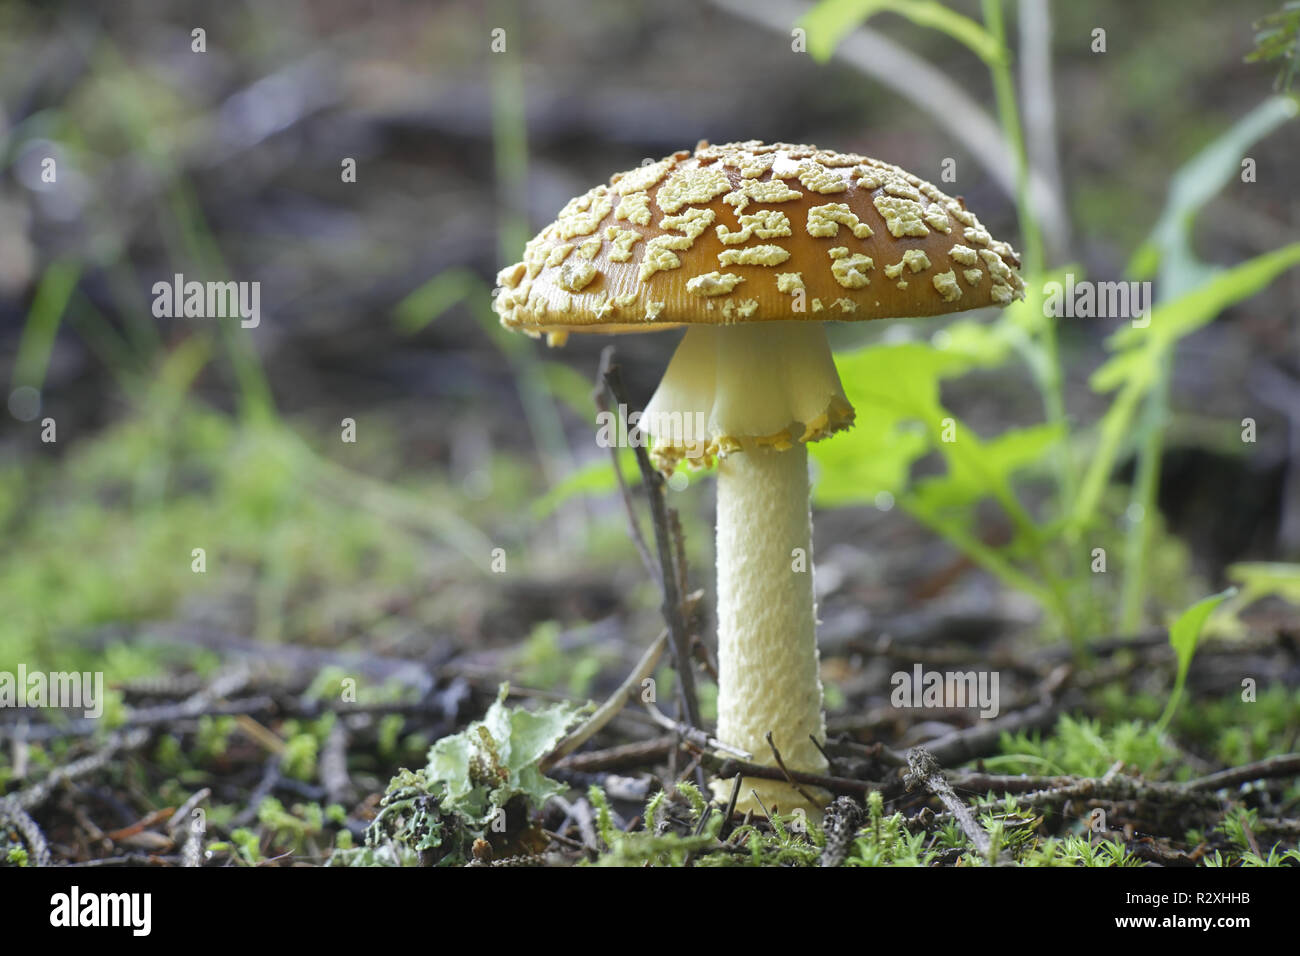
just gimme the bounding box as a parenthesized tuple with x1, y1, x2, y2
(494, 140, 1024, 338)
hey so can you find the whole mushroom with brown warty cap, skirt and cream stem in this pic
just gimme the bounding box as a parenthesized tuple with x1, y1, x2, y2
(494, 140, 1024, 813)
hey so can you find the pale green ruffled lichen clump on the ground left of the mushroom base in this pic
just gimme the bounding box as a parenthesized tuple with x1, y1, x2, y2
(329, 685, 588, 866)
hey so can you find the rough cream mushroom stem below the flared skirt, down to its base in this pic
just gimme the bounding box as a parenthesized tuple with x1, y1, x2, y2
(714, 442, 826, 813)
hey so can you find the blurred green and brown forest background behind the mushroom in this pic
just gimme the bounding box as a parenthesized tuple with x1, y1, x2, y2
(0, 0, 1300, 863)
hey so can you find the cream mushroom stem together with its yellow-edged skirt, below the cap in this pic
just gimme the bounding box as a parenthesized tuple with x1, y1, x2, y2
(642, 321, 853, 813)
